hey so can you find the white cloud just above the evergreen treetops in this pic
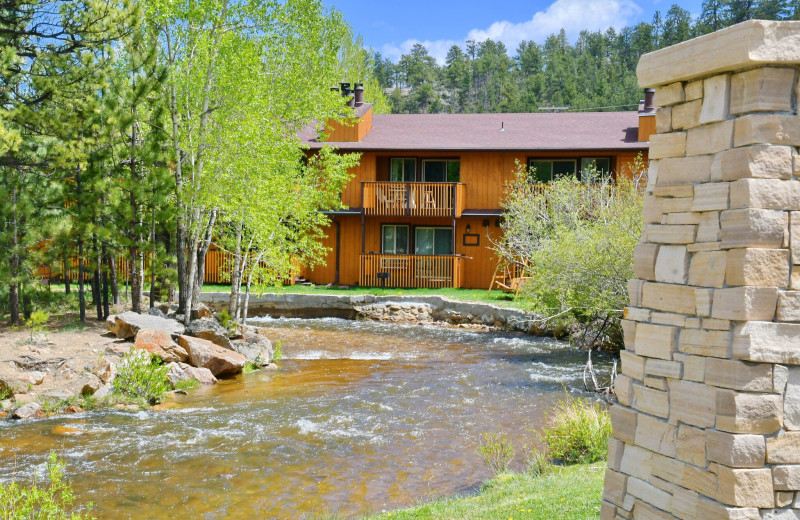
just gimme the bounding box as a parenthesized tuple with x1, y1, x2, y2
(382, 0, 642, 63)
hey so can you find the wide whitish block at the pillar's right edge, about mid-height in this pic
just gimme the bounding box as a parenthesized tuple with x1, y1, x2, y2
(733, 321, 800, 365)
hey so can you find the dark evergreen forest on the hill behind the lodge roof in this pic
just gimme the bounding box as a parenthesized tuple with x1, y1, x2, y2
(373, 0, 800, 114)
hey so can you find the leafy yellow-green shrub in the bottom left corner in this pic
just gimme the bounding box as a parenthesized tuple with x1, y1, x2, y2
(0, 452, 92, 520)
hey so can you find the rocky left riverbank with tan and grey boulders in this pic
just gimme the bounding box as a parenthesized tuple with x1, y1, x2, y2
(0, 305, 275, 419)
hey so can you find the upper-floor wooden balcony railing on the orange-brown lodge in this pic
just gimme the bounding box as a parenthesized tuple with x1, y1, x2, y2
(361, 182, 465, 217)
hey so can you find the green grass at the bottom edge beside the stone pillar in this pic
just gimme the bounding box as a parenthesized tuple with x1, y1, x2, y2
(364, 462, 606, 520)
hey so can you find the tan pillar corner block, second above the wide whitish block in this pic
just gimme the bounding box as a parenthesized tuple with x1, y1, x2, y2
(725, 248, 789, 288)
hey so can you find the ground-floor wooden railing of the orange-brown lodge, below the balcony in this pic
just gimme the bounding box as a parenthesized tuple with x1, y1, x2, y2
(359, 254, 465, 289)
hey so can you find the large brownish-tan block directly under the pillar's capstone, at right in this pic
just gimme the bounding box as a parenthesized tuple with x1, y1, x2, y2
(731, 67, 795, 114)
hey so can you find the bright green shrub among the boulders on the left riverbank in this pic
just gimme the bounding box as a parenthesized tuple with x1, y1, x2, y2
(114, 348, 169, 404)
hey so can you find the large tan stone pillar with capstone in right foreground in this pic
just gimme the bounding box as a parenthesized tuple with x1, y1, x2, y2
(601, 21, 800, 520)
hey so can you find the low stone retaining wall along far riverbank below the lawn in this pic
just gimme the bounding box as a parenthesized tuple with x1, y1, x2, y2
(201, 293, 543, 333)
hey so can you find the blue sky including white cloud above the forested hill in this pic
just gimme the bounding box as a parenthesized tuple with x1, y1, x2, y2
(323, 0, 701, 61)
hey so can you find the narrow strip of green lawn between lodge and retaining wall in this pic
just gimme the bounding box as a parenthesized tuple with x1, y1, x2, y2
(203, 284, 531, 310)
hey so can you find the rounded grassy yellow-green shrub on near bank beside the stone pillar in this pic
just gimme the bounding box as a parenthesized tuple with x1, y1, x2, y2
(539, 396, 611, 464)
